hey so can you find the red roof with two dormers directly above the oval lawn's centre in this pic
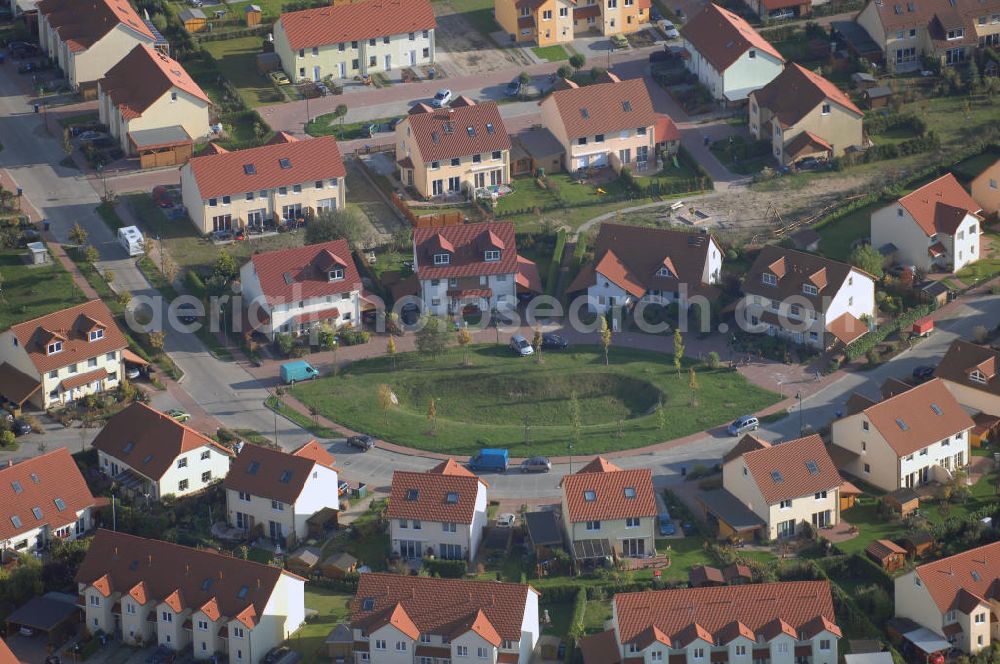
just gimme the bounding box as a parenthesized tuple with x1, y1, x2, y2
(413, 221, 517, 280)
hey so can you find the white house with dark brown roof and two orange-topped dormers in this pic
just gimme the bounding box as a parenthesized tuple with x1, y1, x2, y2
(736, 246, 875, 349)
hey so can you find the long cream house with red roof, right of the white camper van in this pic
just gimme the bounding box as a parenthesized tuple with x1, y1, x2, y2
(181, 136, 347, 233)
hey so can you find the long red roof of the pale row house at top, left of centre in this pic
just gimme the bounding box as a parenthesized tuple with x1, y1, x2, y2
(278, 0, 437, 49)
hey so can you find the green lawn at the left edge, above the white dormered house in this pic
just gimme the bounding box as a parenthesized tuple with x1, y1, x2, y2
(0, 244, 86, 330)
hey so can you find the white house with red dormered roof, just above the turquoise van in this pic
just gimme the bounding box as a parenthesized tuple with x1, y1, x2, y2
(240, 240, 362, 339)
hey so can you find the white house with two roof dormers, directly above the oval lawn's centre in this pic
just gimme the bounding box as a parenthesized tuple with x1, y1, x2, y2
(413, 221, 541, 316)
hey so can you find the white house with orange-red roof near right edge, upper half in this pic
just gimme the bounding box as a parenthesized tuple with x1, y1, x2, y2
(872, 173, 982, 272)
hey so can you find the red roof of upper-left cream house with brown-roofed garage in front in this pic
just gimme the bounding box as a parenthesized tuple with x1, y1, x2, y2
(99, 44, 210, 120)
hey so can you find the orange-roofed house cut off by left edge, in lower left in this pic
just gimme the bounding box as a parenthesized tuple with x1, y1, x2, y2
(0, 447, 107, 553)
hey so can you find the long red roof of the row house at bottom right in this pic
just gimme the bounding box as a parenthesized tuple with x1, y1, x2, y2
(613, 581, 840, 647)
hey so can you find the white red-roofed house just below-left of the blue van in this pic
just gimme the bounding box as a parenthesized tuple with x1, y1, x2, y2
(386, 459, 488, 560)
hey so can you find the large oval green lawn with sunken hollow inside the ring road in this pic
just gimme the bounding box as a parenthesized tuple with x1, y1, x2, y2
(291, 344, 778, 456)
